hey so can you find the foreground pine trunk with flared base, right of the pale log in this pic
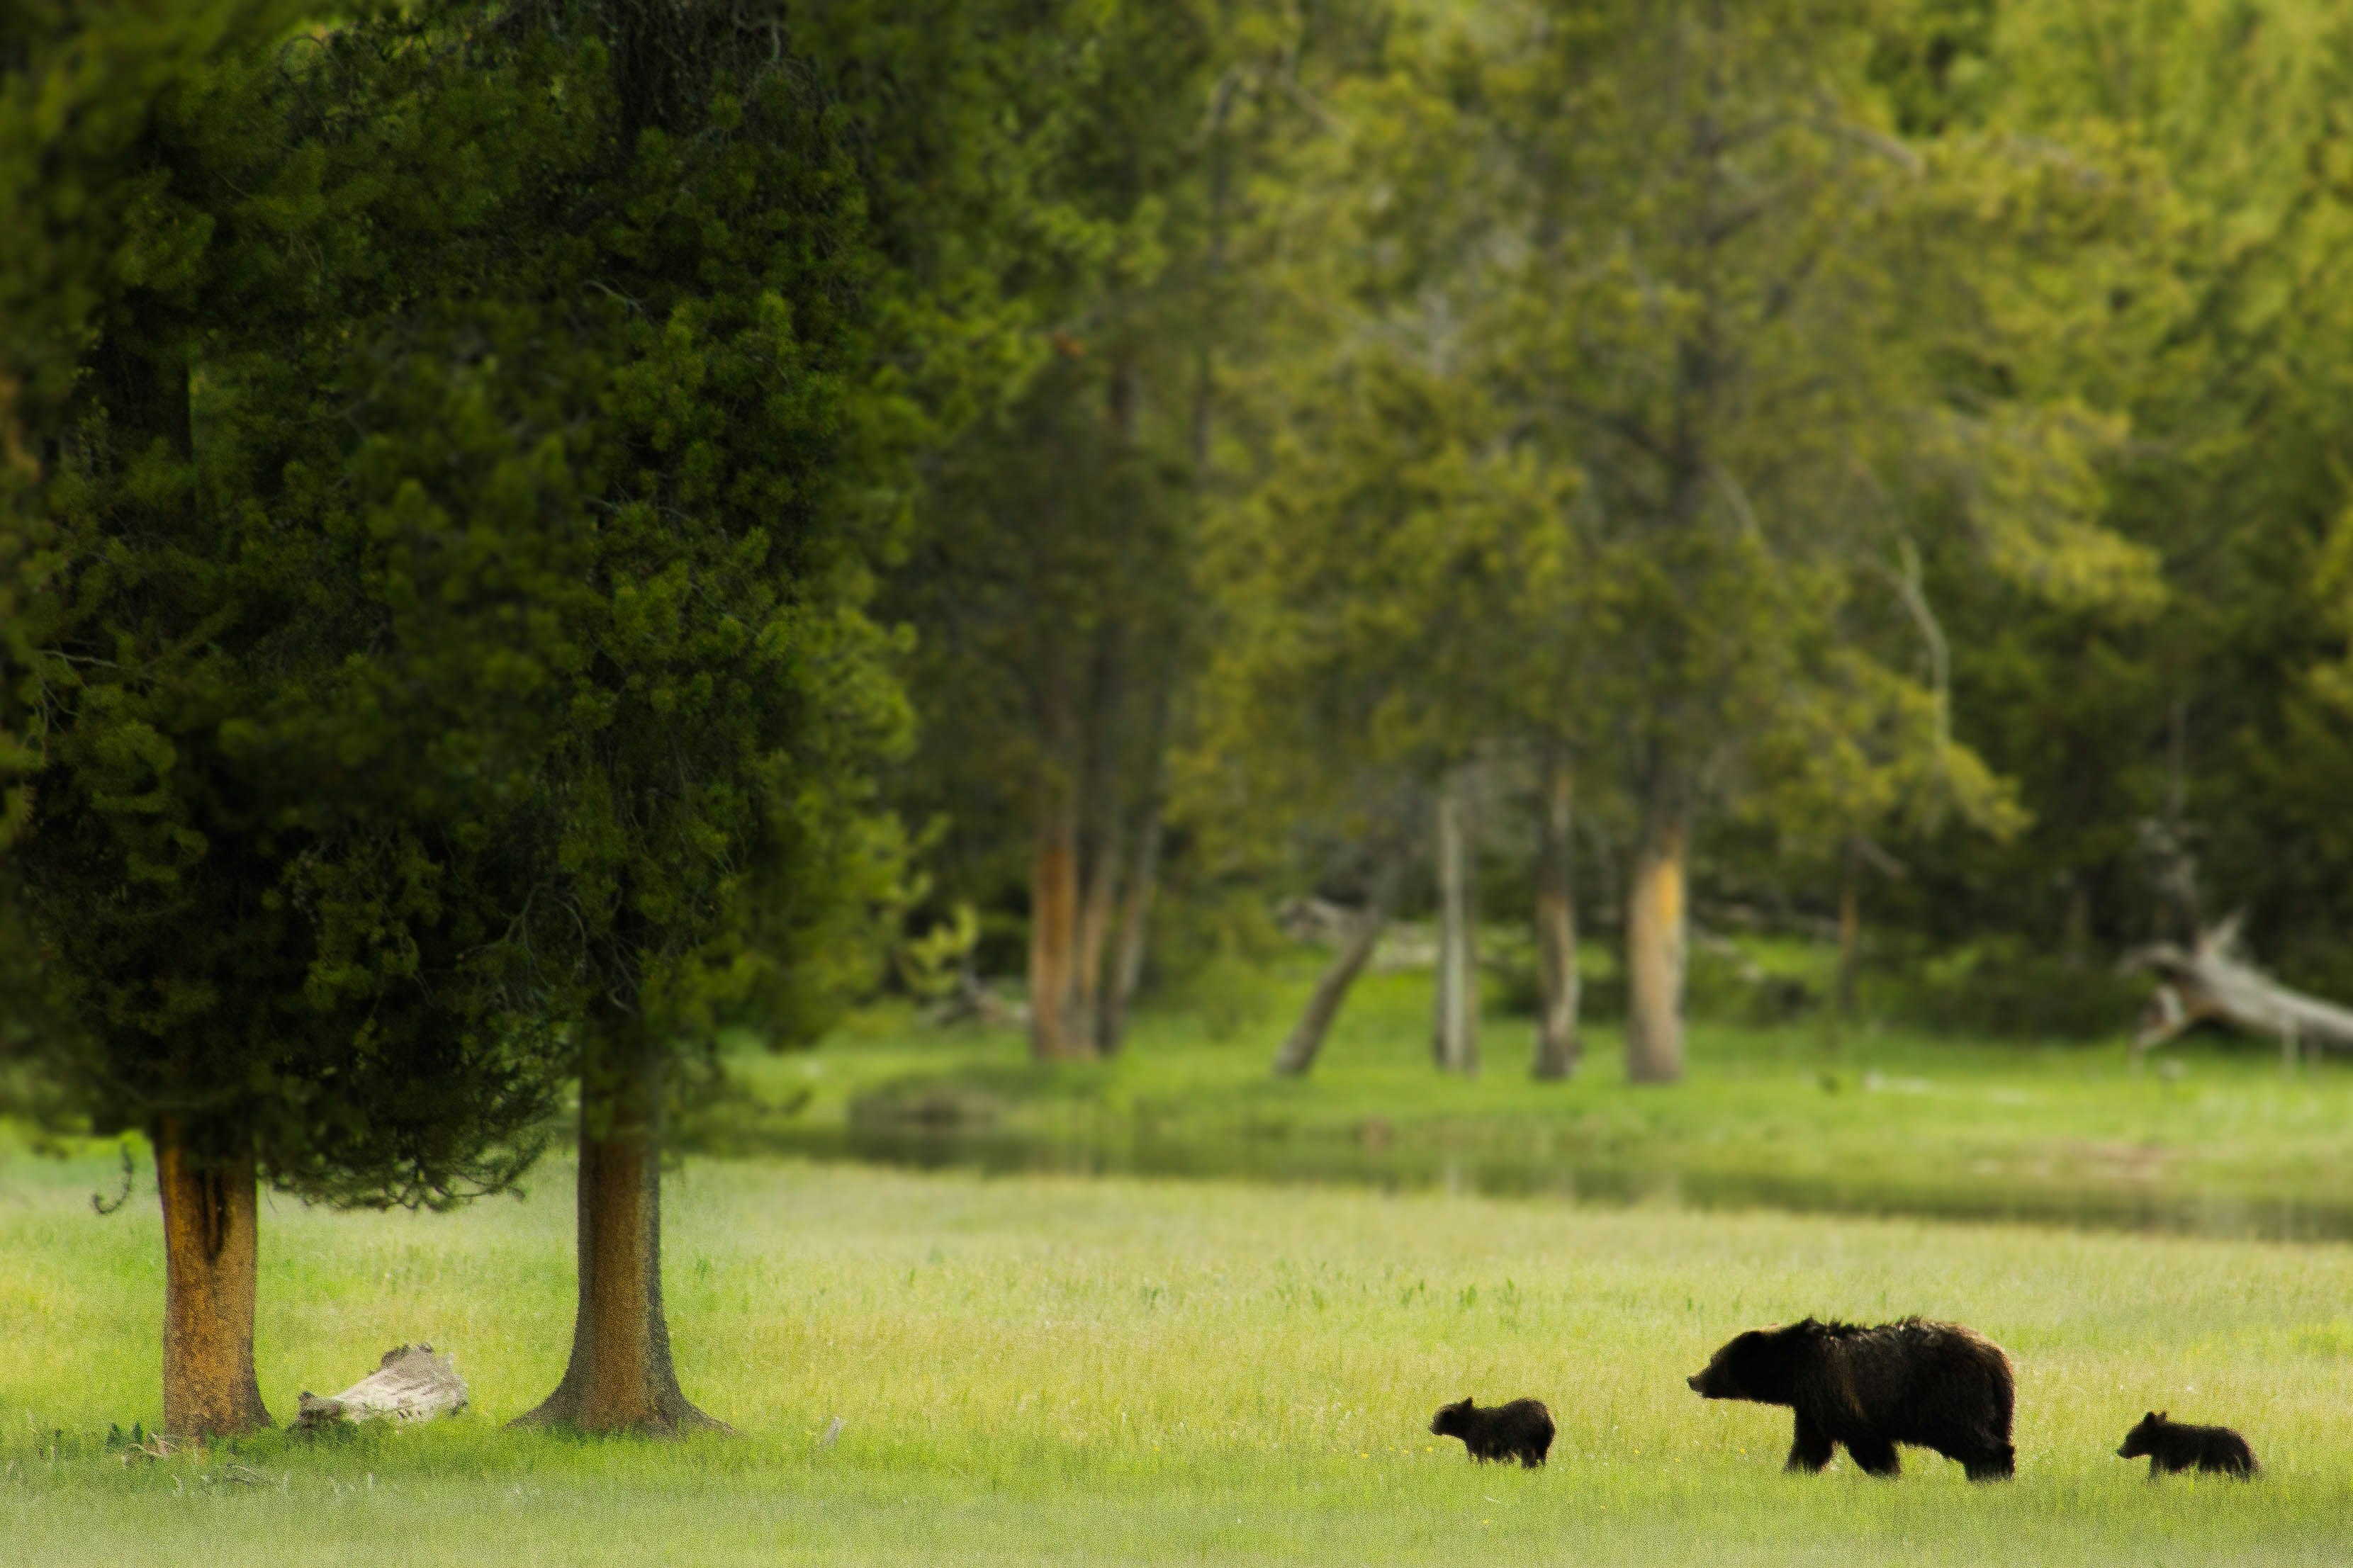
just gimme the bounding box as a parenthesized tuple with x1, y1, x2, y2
(515, 1020, 727, 1434)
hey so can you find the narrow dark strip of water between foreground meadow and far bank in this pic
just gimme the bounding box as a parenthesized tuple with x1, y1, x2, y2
(729, 1126, 2353, 1241)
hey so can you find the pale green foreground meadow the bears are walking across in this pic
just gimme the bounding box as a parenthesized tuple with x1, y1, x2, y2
(0, 1156, 2353, 1566)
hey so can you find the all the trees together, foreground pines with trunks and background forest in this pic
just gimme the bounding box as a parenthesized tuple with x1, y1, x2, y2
(0, 0, 2353, 1432)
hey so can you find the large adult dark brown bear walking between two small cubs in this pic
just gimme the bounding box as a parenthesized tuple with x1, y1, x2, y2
(1690, 1316, 2019, 1481)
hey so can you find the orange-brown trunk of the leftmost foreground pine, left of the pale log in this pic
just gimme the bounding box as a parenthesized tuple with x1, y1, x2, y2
(155, 1117, 271, 1436)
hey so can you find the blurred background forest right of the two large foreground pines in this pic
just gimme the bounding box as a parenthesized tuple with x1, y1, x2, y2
(885, 0, 2353, 1077)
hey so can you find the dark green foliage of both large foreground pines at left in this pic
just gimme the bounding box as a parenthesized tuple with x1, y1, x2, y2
(0, 0, 1000, 1201)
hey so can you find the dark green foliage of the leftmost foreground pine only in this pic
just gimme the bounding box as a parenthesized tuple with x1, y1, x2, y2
(0, 5, 558, 1204)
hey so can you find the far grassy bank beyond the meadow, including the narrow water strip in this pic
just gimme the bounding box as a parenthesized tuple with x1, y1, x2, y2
(690, 961, 2353, 1236)
